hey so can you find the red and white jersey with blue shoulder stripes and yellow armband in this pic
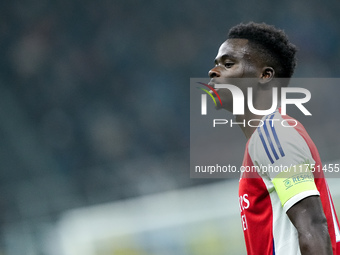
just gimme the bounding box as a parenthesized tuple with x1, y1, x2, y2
(239, 110, 340, 255)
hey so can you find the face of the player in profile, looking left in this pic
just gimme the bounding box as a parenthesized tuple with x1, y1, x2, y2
(209, 39, 261, 111)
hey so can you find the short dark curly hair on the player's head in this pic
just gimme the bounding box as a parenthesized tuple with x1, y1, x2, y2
(228, 22, 297, 78)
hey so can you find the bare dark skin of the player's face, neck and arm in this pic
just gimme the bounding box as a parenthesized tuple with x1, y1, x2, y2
(209, 39, 333, 255)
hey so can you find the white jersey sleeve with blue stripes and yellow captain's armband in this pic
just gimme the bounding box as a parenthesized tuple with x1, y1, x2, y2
(249, 113, 319, 211)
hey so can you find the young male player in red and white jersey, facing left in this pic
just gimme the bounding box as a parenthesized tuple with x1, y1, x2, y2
(209, 23, 340, 255)
